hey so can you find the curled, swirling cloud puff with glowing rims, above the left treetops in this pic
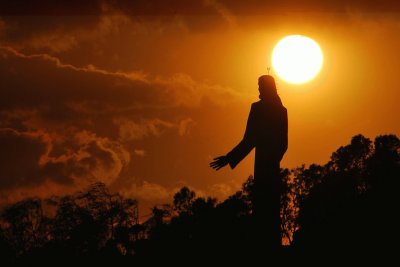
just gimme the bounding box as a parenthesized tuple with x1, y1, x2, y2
(42, 131, 130, 187)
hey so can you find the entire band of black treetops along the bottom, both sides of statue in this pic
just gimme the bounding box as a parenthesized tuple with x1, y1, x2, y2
(0, 135, 400, 265)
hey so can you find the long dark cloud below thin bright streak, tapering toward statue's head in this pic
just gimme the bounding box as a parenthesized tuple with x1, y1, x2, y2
(0, 47, 236, 112)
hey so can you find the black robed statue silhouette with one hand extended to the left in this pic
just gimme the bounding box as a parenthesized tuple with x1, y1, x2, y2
(210, 75, 288, 253)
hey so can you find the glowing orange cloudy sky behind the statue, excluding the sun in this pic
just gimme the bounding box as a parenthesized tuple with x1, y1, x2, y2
(0, 1, 400, 214)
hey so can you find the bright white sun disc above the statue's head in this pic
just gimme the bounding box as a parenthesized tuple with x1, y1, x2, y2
(272, 35, 323, 84)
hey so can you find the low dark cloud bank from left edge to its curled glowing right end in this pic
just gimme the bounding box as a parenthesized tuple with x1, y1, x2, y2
(0, 128, 130, 196)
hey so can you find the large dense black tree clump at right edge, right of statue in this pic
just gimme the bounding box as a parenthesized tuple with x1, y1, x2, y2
(296, 135, 400, 260)
